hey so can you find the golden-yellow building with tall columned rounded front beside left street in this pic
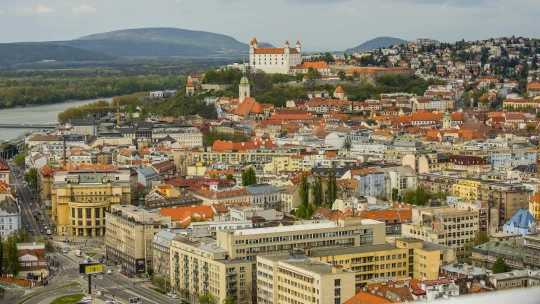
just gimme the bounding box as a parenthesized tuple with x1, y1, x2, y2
(51, 166, 132, 236)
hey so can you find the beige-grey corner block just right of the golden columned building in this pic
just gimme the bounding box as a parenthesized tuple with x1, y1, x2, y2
(105, 205, 170, 273)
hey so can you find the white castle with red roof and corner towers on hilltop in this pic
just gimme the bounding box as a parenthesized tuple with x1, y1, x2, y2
(249, 38, 302, 74)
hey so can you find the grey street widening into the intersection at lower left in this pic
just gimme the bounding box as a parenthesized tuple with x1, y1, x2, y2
(0, 163, 180, 304)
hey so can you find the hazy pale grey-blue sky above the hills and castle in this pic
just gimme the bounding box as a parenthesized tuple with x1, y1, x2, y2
(0, 0, 540, 50)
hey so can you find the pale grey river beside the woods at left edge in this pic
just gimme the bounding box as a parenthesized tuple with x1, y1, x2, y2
(0, 97, 112, 142)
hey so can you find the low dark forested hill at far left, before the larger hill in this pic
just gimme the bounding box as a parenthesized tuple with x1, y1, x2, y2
(0, 43, 114, 68)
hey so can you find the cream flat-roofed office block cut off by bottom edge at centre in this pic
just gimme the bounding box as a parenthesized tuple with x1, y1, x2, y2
(257, 250, 356, 304)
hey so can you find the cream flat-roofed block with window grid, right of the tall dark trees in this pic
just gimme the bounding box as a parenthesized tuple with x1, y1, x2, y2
(401, 207, 478, 260)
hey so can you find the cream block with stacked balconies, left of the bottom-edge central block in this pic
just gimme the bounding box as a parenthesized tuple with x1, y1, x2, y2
(170, 235, 252, 303)
